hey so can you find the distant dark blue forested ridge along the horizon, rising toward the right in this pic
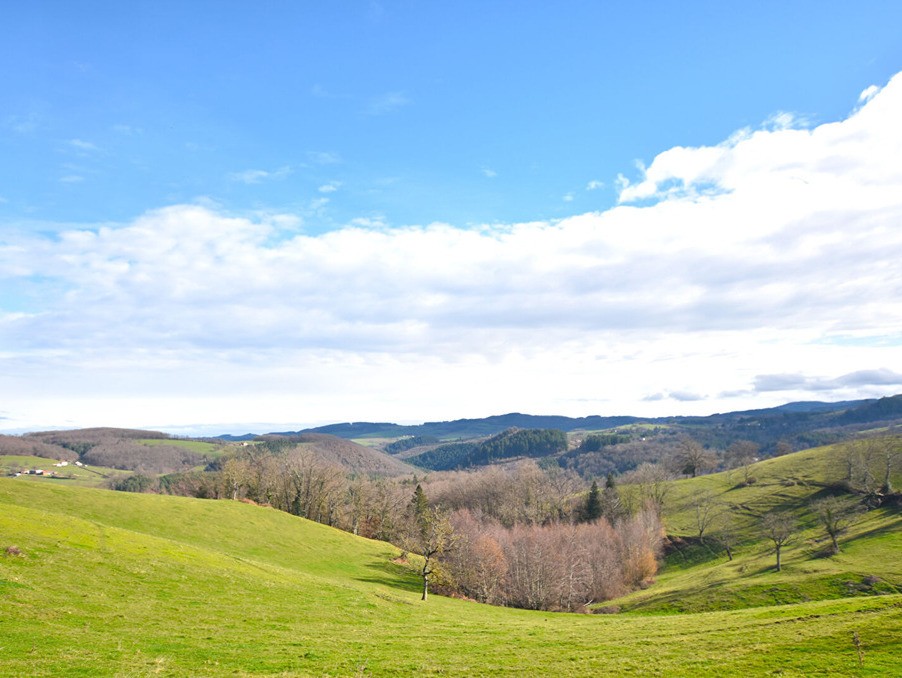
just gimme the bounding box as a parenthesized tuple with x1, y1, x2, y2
(274, 395, 902, 448)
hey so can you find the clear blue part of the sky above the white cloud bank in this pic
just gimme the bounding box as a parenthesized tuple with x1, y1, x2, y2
(7, 2, 902, 230)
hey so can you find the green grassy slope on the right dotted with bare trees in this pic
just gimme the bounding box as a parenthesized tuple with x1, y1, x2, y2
(612, 446, 902, 612)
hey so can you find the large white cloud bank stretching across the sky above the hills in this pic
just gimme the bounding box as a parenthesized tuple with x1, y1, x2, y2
(0, 70, 902, 425)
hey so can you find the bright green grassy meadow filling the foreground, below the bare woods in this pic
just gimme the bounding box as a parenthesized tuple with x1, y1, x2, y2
(0, 479, 902, 676)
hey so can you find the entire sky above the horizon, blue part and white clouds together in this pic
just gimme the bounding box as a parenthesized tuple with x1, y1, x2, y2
(0, 0, 902, 435)
